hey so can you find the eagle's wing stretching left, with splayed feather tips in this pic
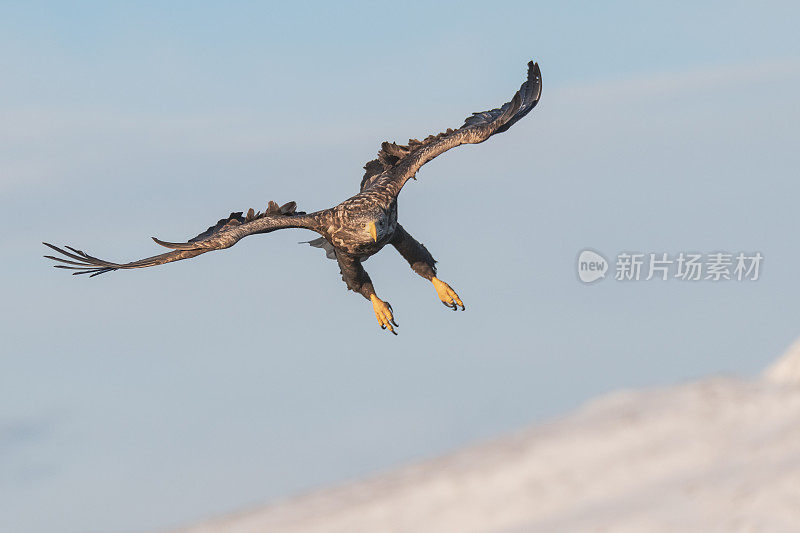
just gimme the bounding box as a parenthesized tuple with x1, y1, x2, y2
(42, 198, 317, 277)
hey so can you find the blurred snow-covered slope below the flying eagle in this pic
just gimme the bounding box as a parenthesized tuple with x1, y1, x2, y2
(169, 344, 800, 533)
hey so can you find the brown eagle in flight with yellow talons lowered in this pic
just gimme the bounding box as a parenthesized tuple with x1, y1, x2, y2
(42, 61, 542, 335)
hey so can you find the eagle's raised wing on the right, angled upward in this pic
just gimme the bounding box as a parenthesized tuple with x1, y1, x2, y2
(361, 61, 542, 191)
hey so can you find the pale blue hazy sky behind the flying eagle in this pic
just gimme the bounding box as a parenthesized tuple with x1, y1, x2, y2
(0, 2, 800, 532)
